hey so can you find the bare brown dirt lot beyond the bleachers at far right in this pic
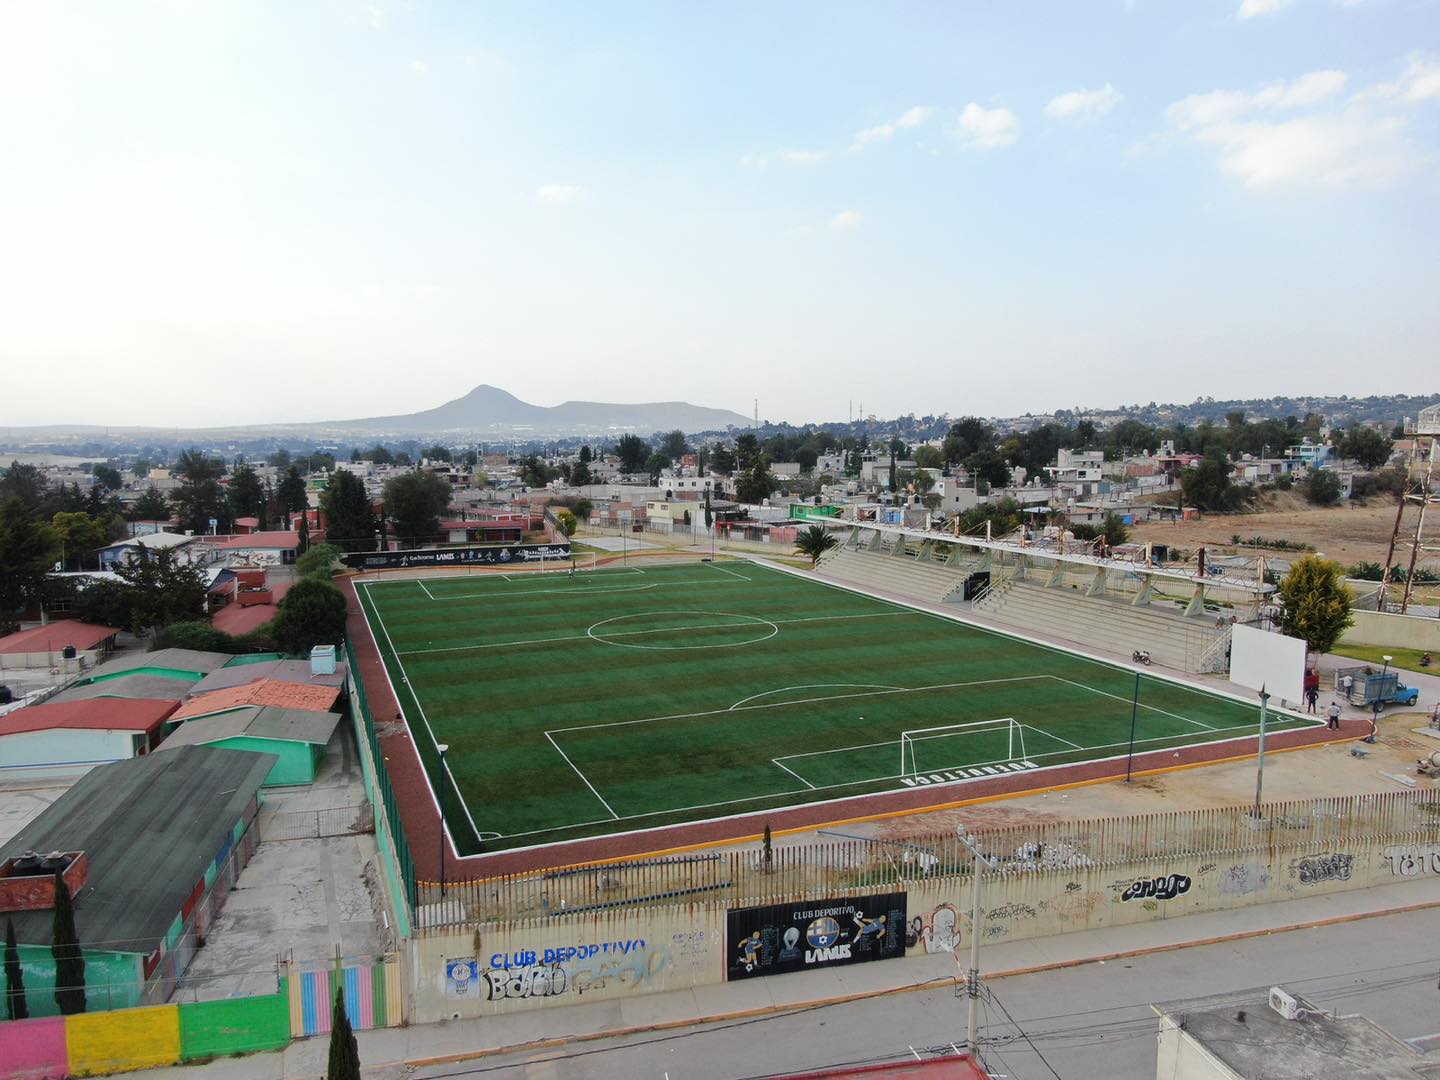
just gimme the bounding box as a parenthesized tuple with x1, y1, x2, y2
(1130, 492, 1440, 569)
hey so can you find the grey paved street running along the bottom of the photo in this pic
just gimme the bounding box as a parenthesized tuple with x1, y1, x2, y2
(434, 909, 1440, 1080)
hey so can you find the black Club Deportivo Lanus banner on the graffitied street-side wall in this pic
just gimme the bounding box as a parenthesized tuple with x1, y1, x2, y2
(726, 893, 906, 979)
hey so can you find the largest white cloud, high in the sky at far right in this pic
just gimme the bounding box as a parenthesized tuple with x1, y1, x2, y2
(1165, 58, 1440, 190)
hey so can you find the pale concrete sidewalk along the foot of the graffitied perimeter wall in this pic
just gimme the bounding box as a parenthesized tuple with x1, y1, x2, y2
(132, 877, 1440, 1080)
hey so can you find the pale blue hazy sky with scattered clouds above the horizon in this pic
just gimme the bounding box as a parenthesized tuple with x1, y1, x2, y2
(0, 0, 1440, 426)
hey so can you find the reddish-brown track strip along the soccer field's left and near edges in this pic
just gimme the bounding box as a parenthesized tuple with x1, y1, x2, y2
(337, 570, 1347, 881)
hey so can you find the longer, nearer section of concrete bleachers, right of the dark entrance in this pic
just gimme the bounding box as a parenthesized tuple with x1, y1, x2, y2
(973, 580, 1228, 671)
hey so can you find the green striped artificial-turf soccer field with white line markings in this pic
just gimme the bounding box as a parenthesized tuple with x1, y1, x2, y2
(357, 562, 1308, 854)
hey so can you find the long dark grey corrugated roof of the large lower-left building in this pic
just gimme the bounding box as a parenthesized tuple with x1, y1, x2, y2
(0, 746, 279, 955)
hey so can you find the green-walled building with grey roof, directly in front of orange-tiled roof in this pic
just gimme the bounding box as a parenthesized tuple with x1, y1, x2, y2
(157, 706, 340, 788)
